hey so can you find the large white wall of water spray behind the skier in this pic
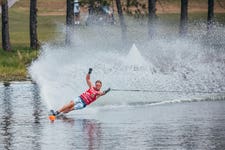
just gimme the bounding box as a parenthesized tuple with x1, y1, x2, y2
(29, 22, 225, 109)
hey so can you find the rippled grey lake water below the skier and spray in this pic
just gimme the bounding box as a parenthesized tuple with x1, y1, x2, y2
(0, 82, 225, 150)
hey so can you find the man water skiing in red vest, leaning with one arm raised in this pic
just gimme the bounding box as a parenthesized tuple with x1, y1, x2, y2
(51, 68, 110, 116)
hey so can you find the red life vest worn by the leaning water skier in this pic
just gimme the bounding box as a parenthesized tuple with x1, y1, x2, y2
(80, 87, 101, 105)
